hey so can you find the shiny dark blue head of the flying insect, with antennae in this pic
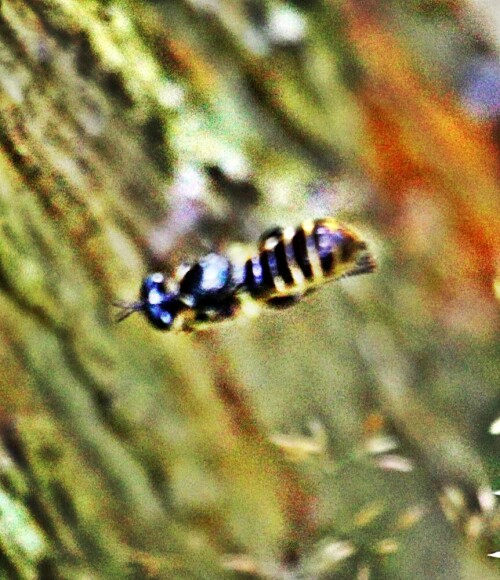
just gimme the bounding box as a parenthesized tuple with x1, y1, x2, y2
(115, 272, 184, 330)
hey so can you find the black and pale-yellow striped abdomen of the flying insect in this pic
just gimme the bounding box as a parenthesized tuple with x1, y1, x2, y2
(243, 218, 375, 301)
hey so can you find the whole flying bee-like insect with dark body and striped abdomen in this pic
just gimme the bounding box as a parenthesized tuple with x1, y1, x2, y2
(116, 217, 376, 331)
